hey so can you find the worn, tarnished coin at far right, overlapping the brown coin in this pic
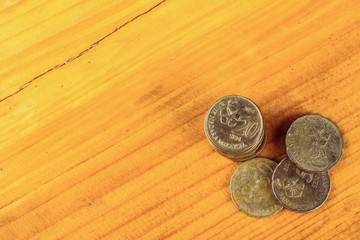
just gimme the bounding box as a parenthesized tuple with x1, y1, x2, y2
(285, 115, 344, 172)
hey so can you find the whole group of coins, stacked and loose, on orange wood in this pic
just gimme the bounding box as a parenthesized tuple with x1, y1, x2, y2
(205, 95, 344, 217)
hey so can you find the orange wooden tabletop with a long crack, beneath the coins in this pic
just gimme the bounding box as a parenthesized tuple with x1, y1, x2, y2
(0, 0, 360, 240)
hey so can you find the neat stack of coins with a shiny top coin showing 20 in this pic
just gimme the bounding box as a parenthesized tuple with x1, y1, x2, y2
(205, 95, 266, 161)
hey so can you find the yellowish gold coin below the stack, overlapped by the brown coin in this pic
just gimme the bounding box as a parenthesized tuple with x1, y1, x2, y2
(230, 158, 282, 217)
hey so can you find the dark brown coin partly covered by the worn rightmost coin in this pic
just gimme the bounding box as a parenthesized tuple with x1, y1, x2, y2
(272, 158, 331, 212)
